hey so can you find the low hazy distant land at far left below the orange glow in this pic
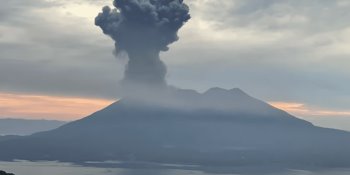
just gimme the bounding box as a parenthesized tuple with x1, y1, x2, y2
(0, 118, 67, 136)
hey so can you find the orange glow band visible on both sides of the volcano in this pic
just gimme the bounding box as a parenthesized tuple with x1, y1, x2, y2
(0, 93, 350, 121)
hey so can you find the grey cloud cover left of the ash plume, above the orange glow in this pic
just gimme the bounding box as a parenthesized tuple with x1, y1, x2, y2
(0, 0, 123, 99)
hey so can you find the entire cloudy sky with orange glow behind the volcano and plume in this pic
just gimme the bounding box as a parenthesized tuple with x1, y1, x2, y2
(0, 0, 350, 130)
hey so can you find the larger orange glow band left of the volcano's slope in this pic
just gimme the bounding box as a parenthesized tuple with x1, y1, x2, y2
(0, 93, 113, 121)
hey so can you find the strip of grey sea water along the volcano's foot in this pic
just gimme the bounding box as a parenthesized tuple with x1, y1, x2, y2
(0, 161, 350, 175)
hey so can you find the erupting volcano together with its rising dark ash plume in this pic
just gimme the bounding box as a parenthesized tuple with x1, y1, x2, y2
(0, 0, 350, 168)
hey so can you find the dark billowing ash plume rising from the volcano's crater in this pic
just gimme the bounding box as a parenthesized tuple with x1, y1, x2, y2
(95, 0, 190, 86)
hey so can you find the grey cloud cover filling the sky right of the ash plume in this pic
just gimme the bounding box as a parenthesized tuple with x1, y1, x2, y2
(165, 0, 350, 109)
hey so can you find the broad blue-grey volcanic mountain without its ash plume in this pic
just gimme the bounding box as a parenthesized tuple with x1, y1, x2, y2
(0, 88, 350, 167)
